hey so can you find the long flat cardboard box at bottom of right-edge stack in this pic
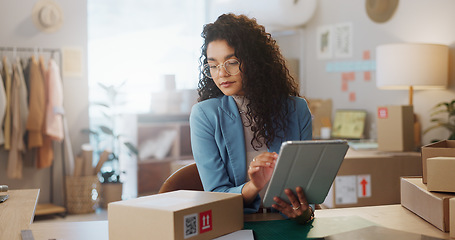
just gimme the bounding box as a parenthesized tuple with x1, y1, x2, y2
(401, 178, 455, 232)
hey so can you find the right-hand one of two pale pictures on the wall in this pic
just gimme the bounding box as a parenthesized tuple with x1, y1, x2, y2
(333, 22, 353, 58)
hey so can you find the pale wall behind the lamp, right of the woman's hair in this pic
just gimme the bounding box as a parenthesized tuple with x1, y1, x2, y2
(209, 0, 455, 144)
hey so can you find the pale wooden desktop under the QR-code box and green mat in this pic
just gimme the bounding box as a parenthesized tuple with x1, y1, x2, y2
(30, 204, 449, 240)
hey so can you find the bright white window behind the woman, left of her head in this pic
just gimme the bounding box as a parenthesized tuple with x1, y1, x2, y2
(87, 0, 206, 113)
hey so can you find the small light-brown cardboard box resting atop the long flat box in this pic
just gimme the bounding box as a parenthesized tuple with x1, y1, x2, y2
(427, 157, 455, 193)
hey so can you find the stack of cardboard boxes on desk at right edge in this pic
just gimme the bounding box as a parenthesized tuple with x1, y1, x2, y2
(401, 140, 455, 238)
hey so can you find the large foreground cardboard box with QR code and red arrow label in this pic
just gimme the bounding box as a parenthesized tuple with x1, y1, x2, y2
(108, 190, 243, 240)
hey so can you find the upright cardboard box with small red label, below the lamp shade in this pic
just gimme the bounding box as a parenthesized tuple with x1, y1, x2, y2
(376, 106, 415, 151)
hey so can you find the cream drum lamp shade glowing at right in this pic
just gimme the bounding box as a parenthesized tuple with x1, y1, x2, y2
(376, 43, 449, 90)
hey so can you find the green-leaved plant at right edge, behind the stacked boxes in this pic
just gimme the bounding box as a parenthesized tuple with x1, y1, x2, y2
(424, 100, 455, 142)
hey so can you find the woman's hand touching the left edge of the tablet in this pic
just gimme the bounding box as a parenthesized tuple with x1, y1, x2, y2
(248, 152, 278, 191)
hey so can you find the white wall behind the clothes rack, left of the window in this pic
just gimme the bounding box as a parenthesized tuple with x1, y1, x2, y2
(0, 0, 88, 204)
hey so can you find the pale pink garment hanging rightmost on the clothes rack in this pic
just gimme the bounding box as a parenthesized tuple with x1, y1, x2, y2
(45, 59, 64, 141)
